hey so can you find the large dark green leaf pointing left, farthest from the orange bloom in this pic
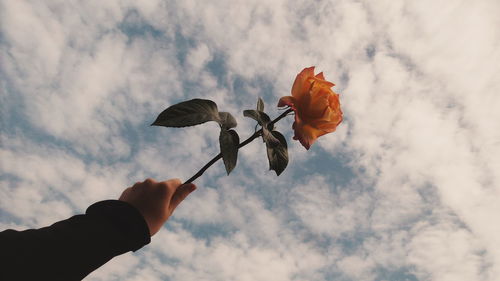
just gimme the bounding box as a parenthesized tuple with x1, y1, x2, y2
(151, 99, 220, 128)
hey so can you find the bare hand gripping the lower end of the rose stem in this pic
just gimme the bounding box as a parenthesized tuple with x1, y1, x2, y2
(118, 179, 196, 236)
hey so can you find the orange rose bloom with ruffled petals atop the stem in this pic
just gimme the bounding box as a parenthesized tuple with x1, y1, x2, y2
(278, 66, 342, 149)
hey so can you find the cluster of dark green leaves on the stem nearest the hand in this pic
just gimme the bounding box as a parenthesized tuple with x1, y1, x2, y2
(151, 99, 240, 175)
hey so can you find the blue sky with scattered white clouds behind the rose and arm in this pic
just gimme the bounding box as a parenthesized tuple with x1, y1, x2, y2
(0, 0, 500, 281)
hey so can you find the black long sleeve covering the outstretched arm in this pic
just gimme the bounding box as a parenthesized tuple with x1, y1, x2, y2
(0, 200, 151, 281)
